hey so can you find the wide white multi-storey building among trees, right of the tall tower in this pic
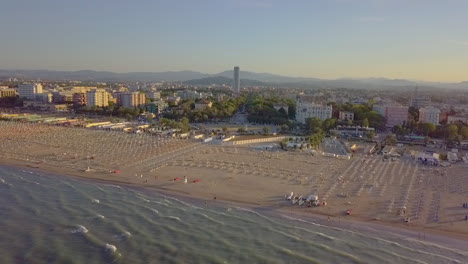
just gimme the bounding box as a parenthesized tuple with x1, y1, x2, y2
(296, 97, 333, 124)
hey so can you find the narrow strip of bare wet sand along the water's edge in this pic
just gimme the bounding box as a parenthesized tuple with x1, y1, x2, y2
(0, 157, 468, 252)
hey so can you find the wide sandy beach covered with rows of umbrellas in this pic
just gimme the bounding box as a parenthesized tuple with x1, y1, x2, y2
(0, 122, 468, 250)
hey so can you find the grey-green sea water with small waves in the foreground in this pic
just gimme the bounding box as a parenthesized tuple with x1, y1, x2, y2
(0, 166, 468, 264)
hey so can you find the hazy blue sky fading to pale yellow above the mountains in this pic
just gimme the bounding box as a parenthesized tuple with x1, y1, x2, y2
(0, 0, 468, 81)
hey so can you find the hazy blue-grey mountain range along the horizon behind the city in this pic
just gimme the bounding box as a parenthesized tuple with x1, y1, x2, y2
(0, 69, 468, 89)
